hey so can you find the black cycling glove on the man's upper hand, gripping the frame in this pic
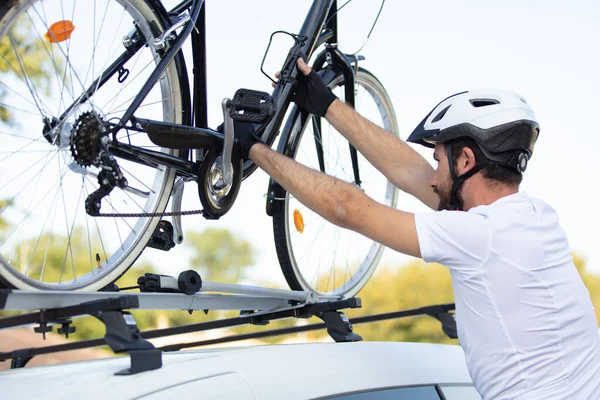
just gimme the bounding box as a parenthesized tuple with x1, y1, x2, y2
(292, 70, 337, 117)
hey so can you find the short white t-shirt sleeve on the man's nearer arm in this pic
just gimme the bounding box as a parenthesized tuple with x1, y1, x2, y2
(415, 211, 490, 270)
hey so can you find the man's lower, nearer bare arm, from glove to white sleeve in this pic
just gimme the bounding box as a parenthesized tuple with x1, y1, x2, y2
(249, 144, 421, 257)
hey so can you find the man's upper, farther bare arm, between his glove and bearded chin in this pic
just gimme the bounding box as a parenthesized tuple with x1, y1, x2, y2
(325, 100, 438, 209)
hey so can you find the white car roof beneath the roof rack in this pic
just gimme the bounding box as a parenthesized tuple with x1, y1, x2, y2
(0, 342, 471, 399)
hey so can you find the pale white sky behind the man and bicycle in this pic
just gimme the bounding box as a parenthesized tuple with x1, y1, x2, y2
(130, 0, 600, 285)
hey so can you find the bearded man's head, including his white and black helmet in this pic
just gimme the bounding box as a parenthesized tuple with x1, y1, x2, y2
(408, 89, 539, 209)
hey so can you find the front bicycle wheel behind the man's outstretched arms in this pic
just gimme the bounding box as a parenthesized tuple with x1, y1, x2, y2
(273, 69, 398, 297)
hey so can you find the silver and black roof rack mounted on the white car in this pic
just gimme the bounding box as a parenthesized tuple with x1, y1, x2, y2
(0, 271, 456, 375)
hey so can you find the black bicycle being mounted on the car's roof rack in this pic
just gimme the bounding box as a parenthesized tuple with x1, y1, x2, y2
(0, 0, 398, 296)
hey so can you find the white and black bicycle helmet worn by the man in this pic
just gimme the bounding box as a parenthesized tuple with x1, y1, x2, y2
(407, 89, 540, 172)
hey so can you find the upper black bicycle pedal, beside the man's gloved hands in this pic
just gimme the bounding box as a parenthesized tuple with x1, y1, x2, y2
(227, 89, 275, 124)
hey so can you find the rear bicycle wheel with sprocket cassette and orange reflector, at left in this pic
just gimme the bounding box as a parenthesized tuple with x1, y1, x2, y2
(0, 0, 182, 290)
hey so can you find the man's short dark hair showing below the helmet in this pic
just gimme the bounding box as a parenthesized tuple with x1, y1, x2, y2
(445, 137, 523, 186)
